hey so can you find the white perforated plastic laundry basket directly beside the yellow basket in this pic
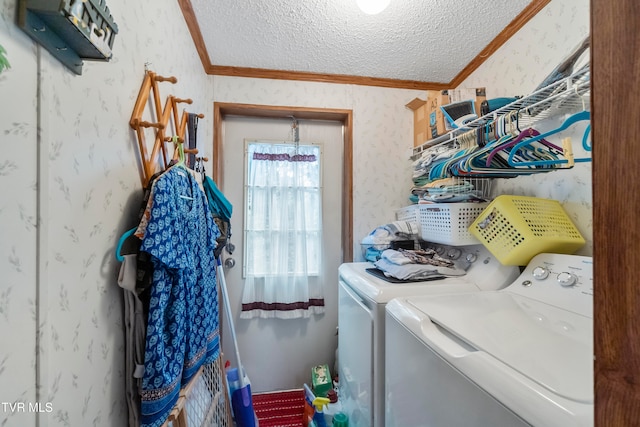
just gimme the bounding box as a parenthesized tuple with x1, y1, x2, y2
(418, 203, 489, 246)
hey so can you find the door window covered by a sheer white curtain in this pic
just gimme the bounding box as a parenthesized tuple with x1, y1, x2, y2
(243, 141, 322, 277)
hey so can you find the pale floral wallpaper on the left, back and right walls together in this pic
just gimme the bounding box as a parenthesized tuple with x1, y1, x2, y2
(0, 0, 591, 427)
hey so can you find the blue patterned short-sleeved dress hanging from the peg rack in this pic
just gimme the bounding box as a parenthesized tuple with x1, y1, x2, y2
(140, 167, 220, 427)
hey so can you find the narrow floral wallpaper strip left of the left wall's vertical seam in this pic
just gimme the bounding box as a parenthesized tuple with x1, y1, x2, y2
(0, 1, 38, 427)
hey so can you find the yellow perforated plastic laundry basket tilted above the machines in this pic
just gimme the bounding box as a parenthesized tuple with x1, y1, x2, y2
(469, 195, 585, 265)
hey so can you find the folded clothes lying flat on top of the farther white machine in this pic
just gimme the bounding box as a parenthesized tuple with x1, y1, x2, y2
(374, 249, 466, 281)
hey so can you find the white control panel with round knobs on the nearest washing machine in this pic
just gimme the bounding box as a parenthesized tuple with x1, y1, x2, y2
(507, 254, 593, 317)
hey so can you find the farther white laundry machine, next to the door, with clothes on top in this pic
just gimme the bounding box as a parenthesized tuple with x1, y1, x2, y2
(338, 244, 520, 427)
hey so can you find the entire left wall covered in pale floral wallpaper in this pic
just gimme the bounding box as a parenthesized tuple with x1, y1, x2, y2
(0, 0, 212, 427)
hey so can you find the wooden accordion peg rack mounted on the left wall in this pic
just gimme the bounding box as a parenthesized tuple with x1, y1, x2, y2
(129, 70, 206, 187)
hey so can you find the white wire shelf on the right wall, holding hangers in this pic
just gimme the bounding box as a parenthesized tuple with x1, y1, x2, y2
(412, 64, 590, 160)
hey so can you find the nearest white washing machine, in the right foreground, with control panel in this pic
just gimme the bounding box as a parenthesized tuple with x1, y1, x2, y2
(385, 254, 594, 427)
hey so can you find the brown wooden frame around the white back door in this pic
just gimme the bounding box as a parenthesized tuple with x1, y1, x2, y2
(212, 102, 353, 262)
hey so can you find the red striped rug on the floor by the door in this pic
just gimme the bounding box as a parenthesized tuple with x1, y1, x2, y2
(252, 389, 304, 427)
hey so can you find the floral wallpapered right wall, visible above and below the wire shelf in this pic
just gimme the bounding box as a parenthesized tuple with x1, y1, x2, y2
(461, 0, 593, 255)
